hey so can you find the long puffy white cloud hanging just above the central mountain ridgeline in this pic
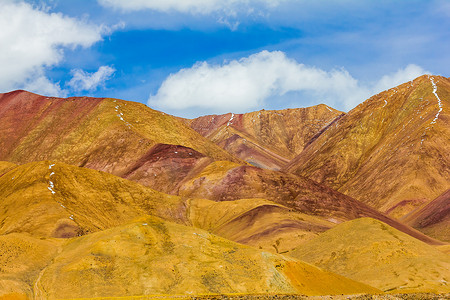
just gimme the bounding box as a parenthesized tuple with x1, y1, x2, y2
(148, 51, 423, 113)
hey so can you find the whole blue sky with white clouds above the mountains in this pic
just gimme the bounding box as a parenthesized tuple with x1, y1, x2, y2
(0, 0, 450, 117)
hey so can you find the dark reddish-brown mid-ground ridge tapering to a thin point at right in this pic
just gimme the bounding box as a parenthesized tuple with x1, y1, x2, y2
(180, 161, 440, 244)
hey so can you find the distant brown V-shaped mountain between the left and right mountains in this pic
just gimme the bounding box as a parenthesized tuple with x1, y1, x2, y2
(185, 104, 342, 170)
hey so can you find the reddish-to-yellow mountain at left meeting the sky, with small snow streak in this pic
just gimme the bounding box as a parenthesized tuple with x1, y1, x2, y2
(0, 91, 239, 192)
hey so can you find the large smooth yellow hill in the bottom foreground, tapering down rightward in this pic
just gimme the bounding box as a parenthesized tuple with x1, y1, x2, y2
(35, 217, 377, 299)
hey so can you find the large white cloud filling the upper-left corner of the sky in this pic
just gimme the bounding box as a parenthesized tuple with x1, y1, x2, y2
(0, 0, 104, 96)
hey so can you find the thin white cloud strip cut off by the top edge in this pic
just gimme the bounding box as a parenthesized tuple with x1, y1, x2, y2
(98, 0, 285, 15)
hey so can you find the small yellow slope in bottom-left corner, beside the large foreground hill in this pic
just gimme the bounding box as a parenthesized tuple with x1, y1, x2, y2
(0, 233, 63, 299)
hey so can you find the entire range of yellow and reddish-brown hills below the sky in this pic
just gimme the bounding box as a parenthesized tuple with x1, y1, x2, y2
(0, 75, 450, 300)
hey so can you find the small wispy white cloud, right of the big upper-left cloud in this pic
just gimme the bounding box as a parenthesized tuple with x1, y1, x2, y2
(67, 66, 116, 92)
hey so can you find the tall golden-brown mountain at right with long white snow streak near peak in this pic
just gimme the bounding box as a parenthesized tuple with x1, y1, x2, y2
(286, 75, 450, 217)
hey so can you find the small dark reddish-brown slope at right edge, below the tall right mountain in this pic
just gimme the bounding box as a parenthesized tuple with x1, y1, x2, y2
(402, 189, 450, 242)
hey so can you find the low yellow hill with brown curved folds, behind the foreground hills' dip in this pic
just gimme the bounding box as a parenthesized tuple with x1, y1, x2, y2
(188, 198, 335, 253)
